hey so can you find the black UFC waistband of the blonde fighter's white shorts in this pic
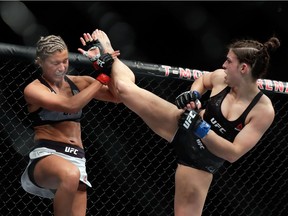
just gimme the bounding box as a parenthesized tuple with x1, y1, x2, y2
(35, 140, 85, 158)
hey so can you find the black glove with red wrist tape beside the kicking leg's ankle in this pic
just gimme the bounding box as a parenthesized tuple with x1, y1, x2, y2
(92, 53, 114, 85)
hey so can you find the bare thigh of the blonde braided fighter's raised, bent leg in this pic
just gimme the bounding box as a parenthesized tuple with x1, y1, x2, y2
(33, 155, 80, 188)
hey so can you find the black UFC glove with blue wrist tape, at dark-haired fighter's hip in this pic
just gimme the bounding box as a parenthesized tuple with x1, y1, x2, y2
(178, 110, 211, 139)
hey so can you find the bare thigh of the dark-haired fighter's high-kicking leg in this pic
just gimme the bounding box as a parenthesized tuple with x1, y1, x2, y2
(115, 79, 182, 141)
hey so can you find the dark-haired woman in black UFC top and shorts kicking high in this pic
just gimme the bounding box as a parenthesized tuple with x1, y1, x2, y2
(80, 30, 280, 216)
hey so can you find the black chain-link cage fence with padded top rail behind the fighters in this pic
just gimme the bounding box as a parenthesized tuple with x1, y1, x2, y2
(0, 43, 288, 216)
